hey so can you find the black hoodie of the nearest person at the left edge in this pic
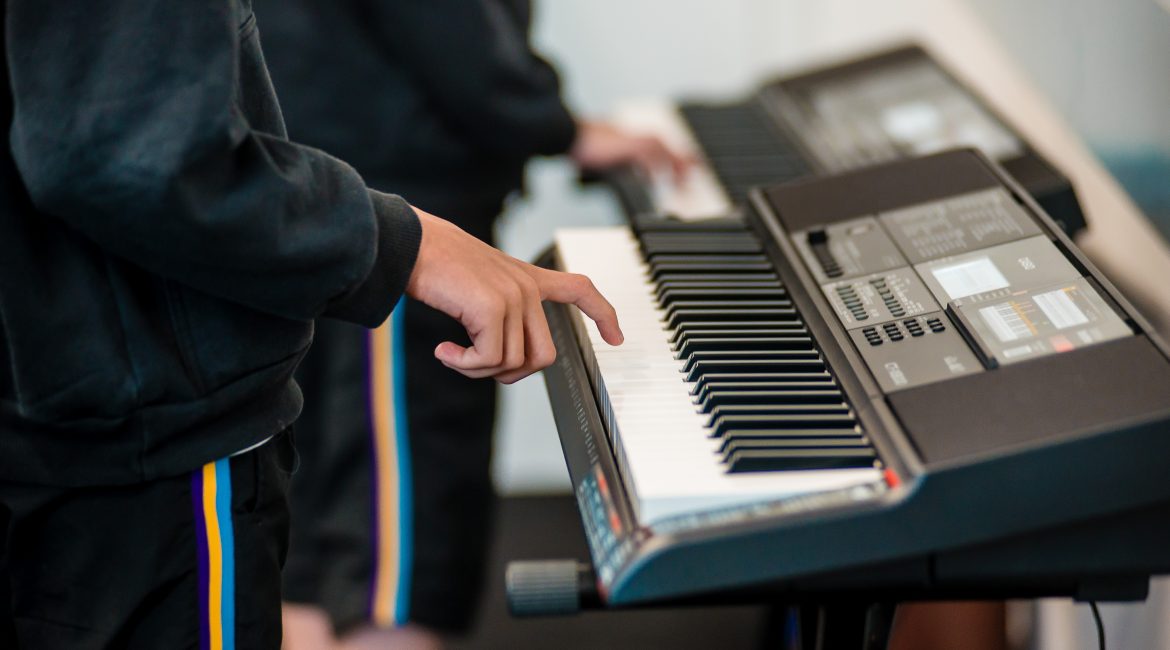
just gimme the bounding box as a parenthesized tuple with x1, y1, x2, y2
(0, 0, 421, 485)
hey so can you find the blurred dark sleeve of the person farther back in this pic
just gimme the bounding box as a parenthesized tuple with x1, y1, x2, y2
(362, 0, 576, 159)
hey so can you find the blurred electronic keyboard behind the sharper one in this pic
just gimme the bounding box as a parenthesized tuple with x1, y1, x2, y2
(604, 46, 1085, 235)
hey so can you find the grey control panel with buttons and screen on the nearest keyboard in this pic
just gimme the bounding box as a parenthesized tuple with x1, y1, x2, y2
(791, 187, 1133, 393)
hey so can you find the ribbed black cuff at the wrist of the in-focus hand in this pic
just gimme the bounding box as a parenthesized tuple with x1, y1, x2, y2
(325, 189, 422, 327)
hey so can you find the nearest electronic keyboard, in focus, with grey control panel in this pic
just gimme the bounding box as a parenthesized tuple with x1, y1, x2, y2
(509, 150, 1170, 614)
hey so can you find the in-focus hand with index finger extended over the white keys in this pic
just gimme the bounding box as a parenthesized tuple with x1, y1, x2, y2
(406, 208, 622, 383)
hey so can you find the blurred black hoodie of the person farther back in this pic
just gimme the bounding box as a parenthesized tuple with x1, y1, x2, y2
(255, 0, 576, 212)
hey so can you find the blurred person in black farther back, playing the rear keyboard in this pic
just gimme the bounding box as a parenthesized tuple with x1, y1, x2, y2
(256, 0, 686, 650)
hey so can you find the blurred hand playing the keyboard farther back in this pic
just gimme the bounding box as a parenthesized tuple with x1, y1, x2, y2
(569, 119, 694, 182)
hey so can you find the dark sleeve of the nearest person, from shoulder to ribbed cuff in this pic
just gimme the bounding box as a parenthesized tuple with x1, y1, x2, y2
(5, 0, 421, 326)
